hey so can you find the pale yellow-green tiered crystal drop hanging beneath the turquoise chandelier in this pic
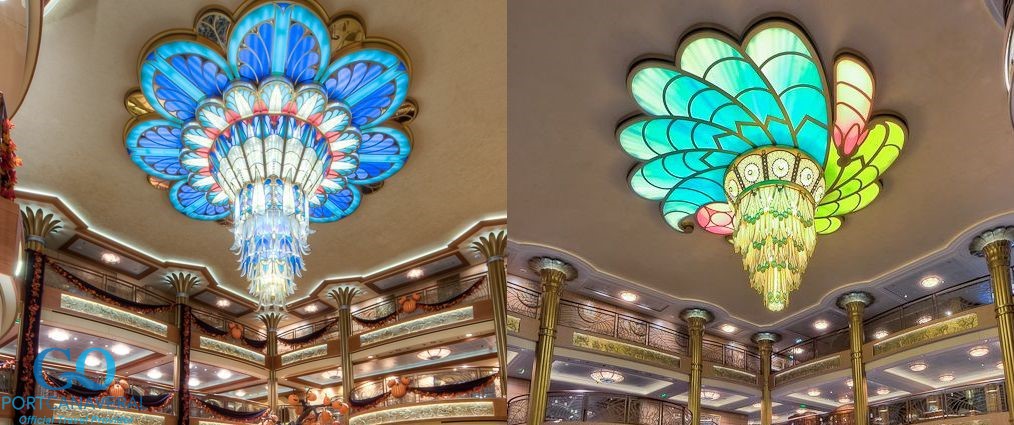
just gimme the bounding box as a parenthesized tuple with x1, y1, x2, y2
(732, 184, 816, 311)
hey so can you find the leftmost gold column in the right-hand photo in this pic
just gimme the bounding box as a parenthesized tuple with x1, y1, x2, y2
(528, 257, 577, 425)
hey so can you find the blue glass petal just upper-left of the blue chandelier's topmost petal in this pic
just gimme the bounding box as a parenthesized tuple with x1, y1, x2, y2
(140, 41, 230, 122)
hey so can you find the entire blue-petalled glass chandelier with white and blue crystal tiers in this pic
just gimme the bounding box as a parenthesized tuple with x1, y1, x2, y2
(125, 0, 415, 308)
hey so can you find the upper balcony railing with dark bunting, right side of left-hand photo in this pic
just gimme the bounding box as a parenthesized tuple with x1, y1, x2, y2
(279, 273, 490, 352)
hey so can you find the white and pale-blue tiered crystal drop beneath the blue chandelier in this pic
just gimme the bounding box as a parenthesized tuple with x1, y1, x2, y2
(232, 179, 312, 306)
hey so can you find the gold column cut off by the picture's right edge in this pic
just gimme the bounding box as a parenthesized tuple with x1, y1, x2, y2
(968, 227, 1014, 424)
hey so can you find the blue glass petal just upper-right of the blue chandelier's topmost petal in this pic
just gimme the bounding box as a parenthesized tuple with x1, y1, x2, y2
(321, 49, 409, 128)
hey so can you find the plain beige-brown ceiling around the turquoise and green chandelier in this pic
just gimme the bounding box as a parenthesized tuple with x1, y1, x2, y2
(508, 0, 1014, 324)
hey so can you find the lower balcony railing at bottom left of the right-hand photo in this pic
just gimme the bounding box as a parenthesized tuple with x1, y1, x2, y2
(507, 392, 691, 425)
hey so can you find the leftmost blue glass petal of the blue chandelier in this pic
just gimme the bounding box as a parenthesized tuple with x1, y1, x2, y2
(126, 120, 188, 181)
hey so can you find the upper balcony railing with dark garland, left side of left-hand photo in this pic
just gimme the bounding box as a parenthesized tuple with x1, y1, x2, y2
(46, 259, 174, 324)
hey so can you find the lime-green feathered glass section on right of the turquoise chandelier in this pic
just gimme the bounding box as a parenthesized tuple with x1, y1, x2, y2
(815, 117, 908, 217)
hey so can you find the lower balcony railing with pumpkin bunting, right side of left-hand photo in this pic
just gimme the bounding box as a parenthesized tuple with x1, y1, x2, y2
(352, 367, 503, 410)
